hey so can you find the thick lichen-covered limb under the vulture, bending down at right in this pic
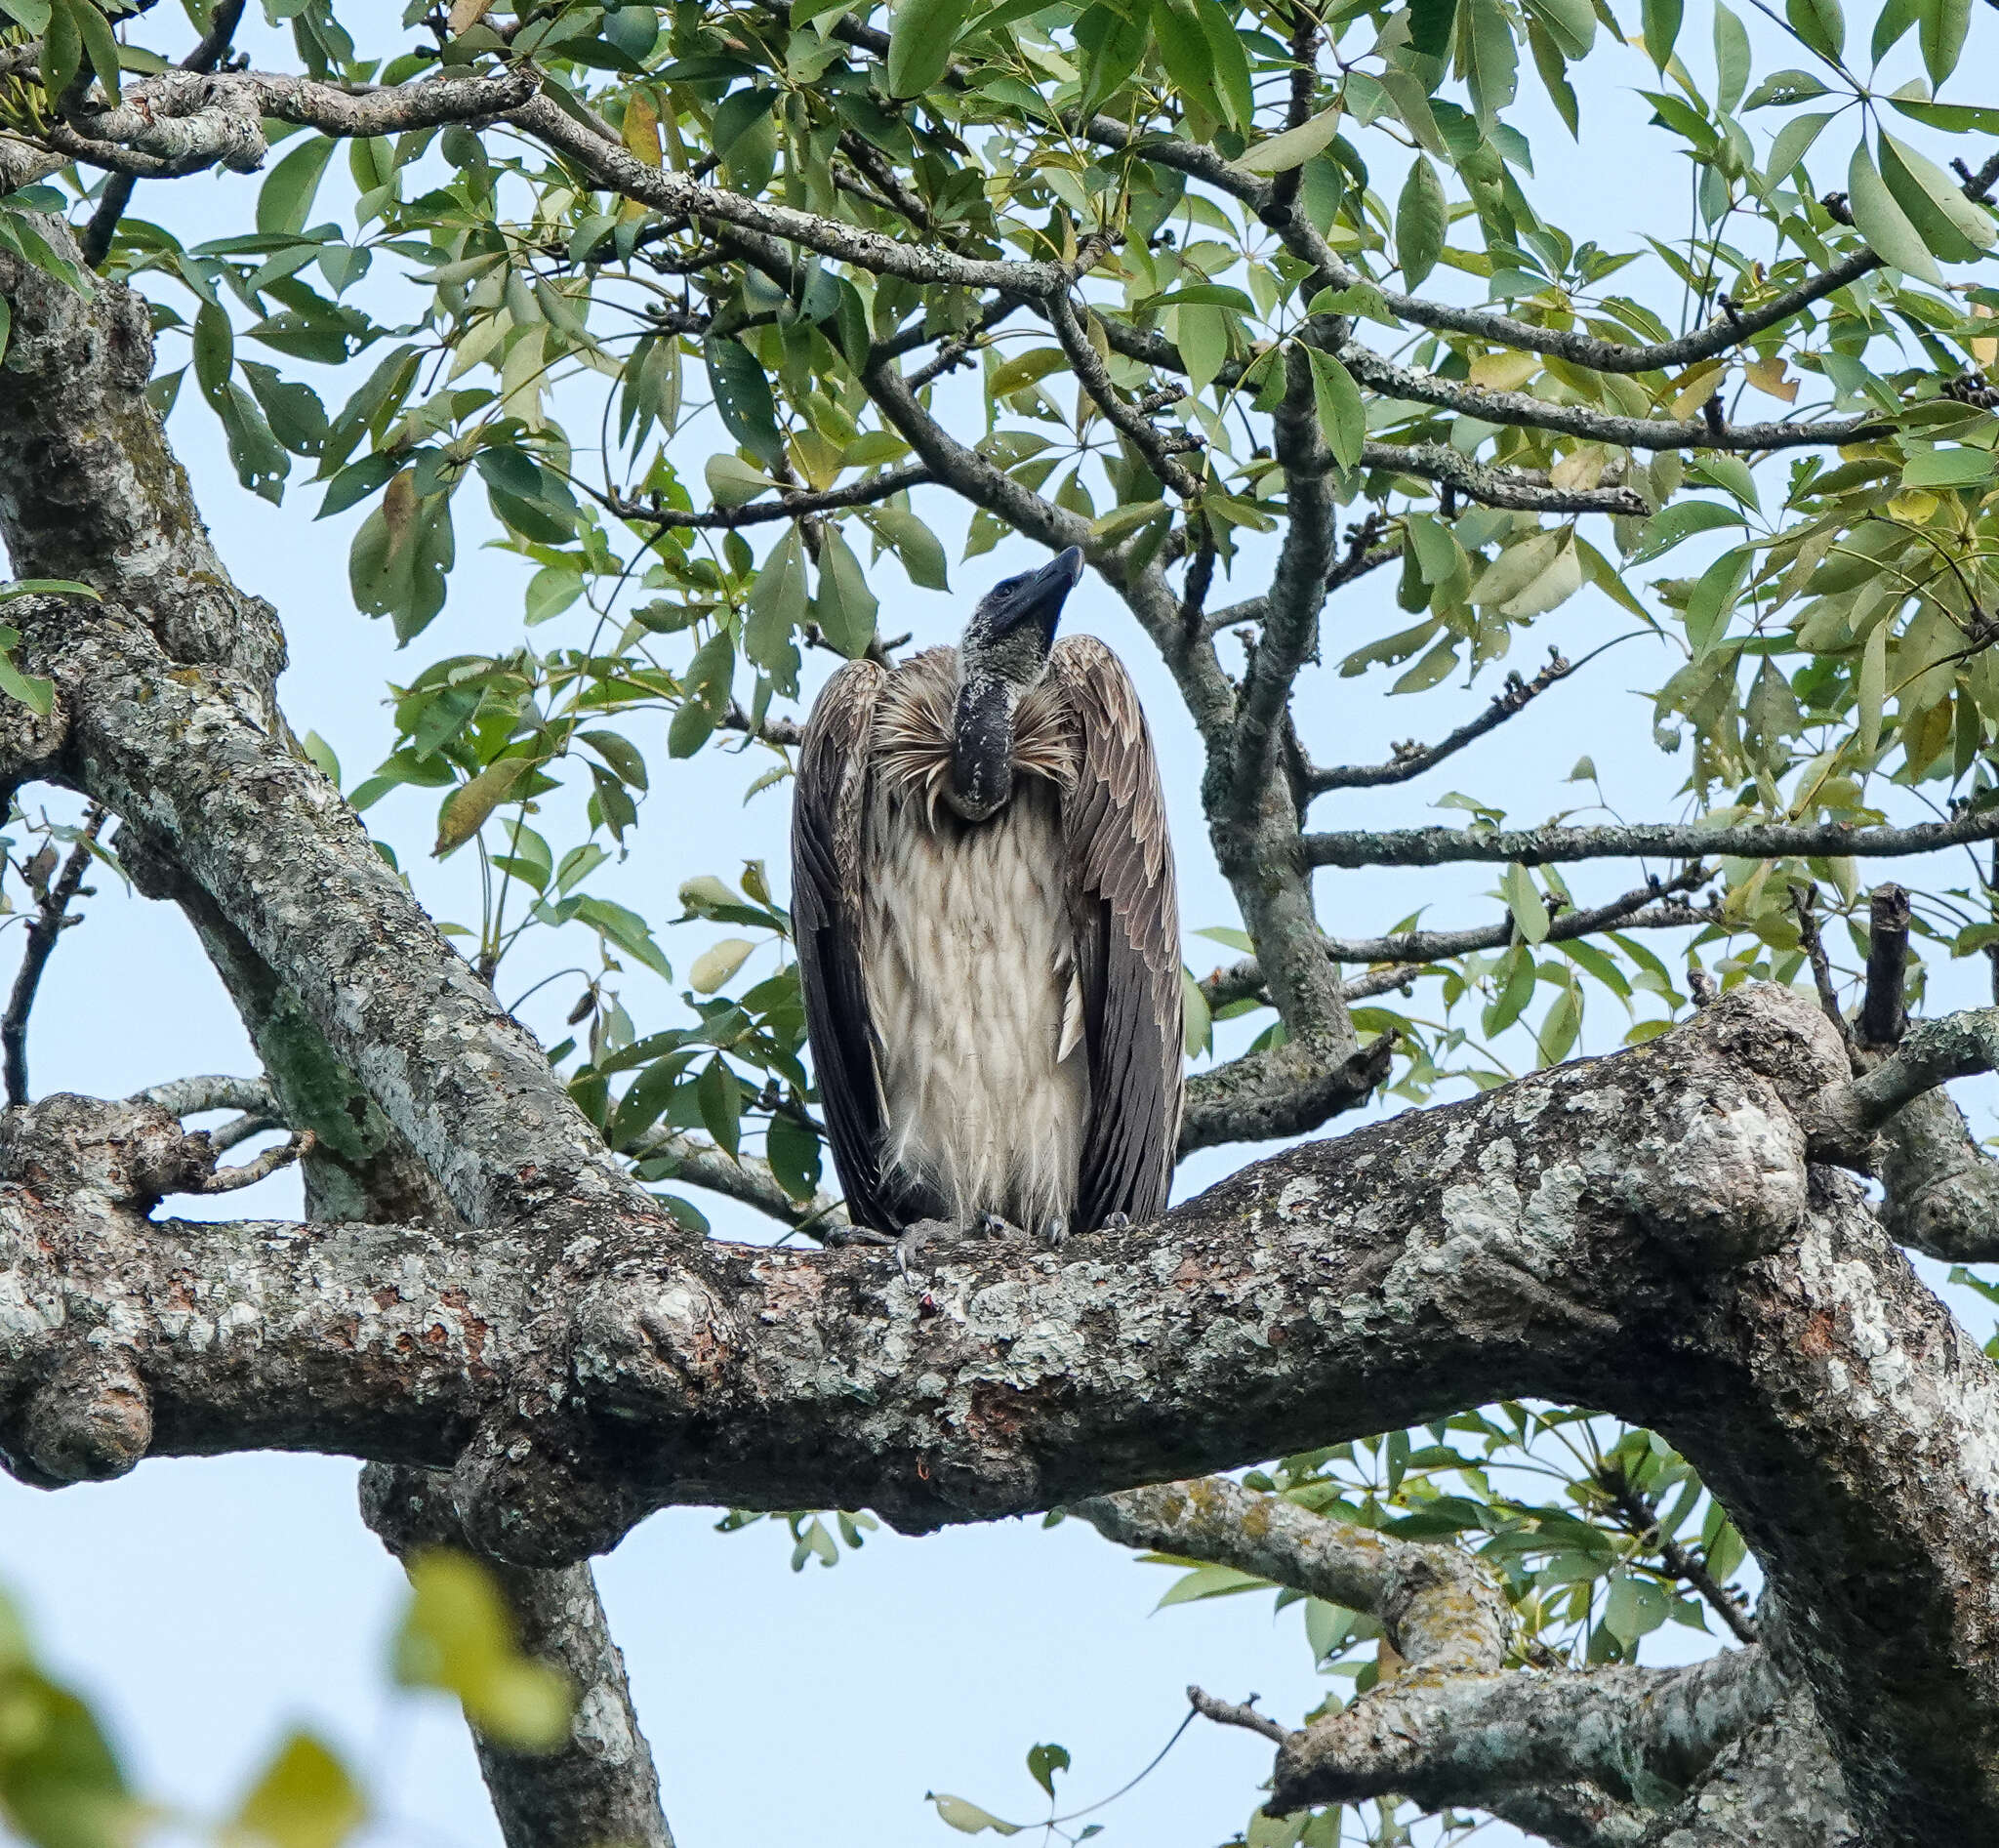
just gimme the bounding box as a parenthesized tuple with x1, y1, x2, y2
(0, 990, 1999, 1842)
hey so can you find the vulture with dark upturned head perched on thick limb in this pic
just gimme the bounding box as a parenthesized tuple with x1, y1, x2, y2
(792, 546, 1181, 1242)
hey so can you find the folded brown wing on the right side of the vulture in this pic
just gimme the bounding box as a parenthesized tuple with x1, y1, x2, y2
(1049, 636, 1183, 1230)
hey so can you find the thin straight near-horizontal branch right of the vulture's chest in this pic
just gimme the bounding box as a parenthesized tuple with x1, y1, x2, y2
(1303, 806, 1999, 866)
